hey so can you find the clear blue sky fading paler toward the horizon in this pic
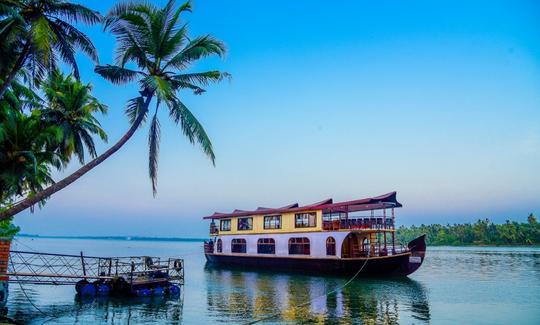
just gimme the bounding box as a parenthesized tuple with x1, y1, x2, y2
(15, 0, 540, 237)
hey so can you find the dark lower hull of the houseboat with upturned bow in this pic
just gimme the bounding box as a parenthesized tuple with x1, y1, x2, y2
(205, 236, 426, 276)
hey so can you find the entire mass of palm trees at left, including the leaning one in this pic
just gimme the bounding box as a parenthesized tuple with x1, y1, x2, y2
(0, 0, 229, 220)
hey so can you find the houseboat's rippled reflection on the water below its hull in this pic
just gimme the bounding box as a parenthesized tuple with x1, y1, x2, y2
(205, 267, 430, 324)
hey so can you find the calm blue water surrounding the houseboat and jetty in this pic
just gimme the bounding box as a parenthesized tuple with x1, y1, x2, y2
(8, 238, 540, 324)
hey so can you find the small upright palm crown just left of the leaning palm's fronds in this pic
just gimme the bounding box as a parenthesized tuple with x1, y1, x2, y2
(41, 71, 107, 164)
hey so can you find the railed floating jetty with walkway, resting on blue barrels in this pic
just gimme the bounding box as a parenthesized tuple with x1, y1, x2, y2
(4, 251, 184, 297)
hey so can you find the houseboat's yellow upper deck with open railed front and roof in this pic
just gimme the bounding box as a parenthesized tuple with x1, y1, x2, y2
(204, 192, 402, 236)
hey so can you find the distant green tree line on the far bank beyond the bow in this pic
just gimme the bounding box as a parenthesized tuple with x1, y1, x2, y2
(397, 214, 540, 245)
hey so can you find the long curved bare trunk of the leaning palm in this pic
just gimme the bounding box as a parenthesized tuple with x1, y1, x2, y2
(0, 95, 152, 220)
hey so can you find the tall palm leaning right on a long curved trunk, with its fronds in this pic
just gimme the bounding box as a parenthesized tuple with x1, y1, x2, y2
(0, 0, 229, 219)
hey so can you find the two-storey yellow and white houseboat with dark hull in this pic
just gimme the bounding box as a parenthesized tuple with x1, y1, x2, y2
(203, 192, 426, 276)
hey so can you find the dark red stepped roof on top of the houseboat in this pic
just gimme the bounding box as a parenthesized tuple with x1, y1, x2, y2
(203, 192, 402, 219)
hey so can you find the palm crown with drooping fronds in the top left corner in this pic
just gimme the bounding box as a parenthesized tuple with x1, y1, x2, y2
(0, 0, 101, 98)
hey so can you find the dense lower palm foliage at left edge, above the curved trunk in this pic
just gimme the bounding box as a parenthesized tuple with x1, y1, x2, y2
(0, 71, 107, 208)
